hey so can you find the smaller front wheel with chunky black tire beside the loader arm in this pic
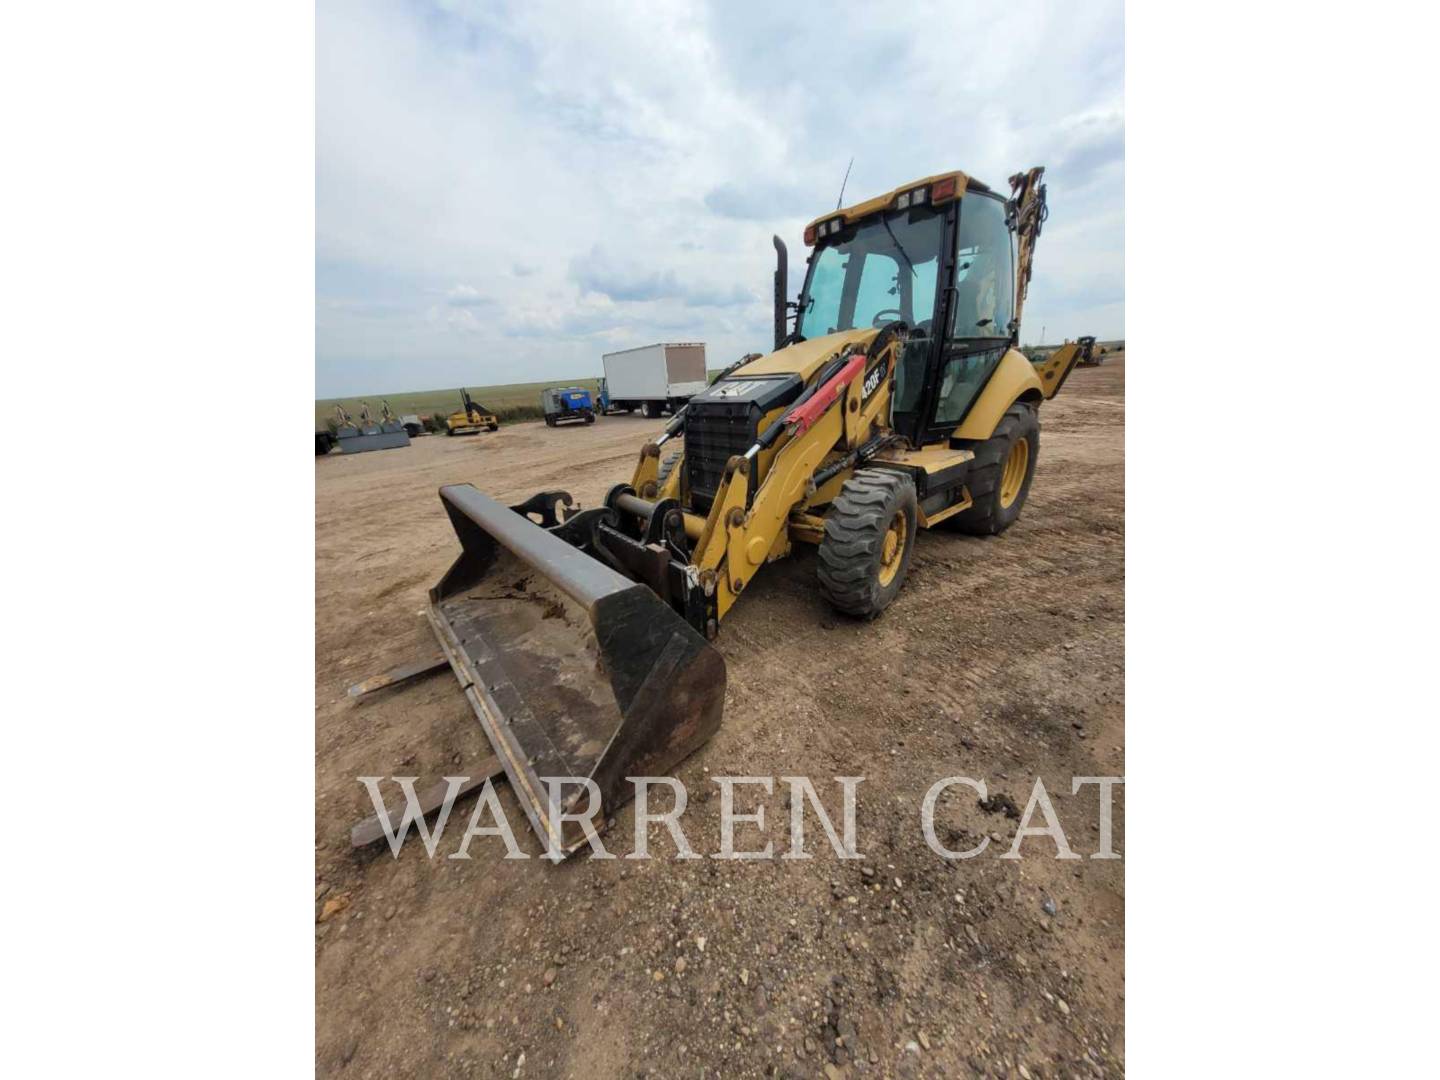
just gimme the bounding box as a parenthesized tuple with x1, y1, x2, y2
(816, 469, 916, 619)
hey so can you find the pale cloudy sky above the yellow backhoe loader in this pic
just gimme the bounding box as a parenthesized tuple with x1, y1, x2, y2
(315, 0, 1125, 397)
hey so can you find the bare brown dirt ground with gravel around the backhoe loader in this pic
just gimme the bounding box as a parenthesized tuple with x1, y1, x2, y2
(315, 357, 1125, 1077)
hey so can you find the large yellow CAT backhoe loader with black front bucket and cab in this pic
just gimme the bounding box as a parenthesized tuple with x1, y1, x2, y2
(429, 168, 1079, 857)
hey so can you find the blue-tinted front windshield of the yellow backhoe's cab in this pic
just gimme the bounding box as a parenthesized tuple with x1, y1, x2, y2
(795, 207, 945, 337)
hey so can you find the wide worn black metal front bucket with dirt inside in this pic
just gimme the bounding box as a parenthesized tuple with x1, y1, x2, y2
(429, 484, 726, 860)
